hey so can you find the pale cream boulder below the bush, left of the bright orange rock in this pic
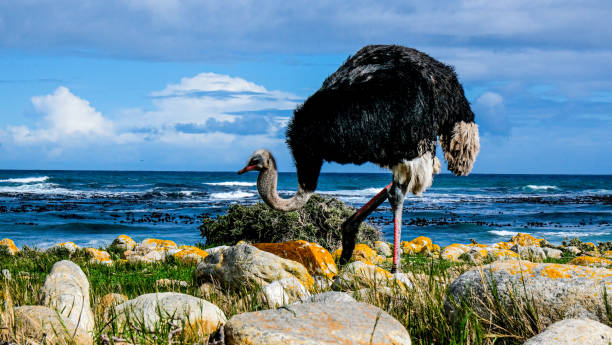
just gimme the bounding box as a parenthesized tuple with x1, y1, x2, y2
(194, 244, 314, 288)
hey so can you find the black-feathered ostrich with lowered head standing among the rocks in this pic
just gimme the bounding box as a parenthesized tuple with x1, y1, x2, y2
(238, 45, 480, 271)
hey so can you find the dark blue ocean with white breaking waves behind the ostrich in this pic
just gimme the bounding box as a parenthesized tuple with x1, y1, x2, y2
(0, 170, 612, 248)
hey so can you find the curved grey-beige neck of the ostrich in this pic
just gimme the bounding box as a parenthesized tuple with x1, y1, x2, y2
(257, 166, 313, 212)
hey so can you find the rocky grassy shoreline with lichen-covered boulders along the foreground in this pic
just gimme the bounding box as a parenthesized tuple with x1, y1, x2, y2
(0, 234, 612, 345)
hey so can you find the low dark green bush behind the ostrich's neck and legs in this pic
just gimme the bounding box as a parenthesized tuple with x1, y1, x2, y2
(200, 194, 381, 250)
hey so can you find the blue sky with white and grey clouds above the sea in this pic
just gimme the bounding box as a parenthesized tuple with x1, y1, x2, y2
(0, 0, 612, 174)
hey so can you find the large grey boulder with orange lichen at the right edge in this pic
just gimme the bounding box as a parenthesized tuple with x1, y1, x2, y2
(446, 260, 612, 325)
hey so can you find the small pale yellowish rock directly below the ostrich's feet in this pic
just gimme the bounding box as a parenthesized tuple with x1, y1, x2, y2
(333, 261, 401, 291)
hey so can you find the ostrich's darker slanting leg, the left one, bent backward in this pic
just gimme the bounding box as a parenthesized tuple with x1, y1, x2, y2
(340, 183, 393, 266)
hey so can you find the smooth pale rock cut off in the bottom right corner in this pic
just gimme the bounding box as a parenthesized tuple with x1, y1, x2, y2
(523, 319, 612, 345)
